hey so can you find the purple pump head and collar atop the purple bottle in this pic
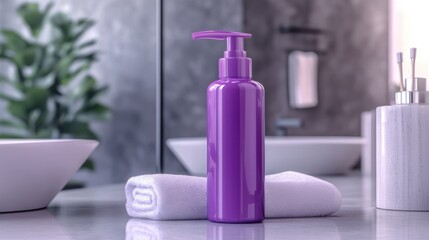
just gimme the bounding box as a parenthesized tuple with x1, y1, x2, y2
(192, 31, 252, 78)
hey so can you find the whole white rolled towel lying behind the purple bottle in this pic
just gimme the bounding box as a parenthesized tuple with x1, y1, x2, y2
(125, 172, 341, 220)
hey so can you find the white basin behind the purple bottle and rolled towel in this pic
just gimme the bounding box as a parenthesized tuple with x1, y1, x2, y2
(167, 137, 364, 176)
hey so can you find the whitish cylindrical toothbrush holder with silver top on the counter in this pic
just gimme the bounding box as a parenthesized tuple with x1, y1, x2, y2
(376, 78, 429, 211)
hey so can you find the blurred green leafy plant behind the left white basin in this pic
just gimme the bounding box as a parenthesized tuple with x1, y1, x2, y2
(0, 3, 110, 170)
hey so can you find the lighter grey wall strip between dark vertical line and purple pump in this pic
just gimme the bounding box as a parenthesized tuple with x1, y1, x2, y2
(164, 0, 243, 173)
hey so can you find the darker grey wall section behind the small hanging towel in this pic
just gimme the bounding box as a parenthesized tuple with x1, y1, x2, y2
(244, 0, 388, 136)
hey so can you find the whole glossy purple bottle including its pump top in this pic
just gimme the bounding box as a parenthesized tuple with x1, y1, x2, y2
(192, 31, 265, 223)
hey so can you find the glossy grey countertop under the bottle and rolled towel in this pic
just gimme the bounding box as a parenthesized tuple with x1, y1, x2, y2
(0, 173, 429, 240)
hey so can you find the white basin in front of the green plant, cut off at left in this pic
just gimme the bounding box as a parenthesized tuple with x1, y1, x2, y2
(0, 139, 98, 213)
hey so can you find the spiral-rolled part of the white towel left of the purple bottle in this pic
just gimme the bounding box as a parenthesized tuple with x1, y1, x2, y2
(125, 174, 207, 220)
